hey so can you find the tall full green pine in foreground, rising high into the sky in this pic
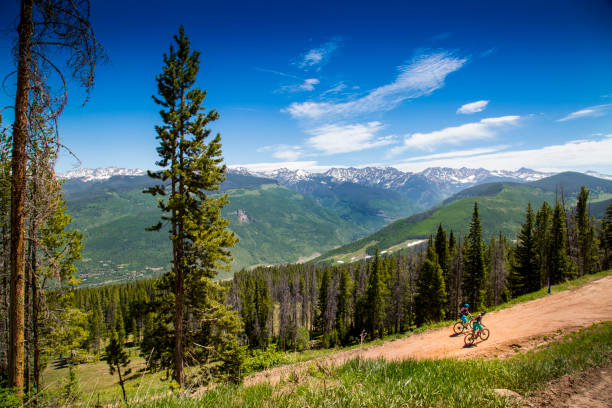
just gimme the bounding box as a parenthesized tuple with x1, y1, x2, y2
(145, 27, 237, 387)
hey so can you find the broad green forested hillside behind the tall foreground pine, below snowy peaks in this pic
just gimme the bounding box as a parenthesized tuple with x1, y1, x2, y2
(64, 175, 368, 285)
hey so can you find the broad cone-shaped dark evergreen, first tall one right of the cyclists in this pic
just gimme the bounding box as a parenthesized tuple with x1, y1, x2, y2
(508, 203, 540, 297)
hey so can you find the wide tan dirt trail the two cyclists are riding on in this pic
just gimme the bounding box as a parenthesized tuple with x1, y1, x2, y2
(246, 276, 612, 384)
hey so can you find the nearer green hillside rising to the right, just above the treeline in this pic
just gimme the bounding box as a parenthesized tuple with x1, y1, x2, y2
(312, 172, 612, 263)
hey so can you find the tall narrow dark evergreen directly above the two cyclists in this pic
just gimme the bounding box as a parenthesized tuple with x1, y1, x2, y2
(462, 203, 487, 310)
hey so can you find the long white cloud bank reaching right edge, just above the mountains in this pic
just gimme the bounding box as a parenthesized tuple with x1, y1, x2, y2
(394, 135, 612, 172)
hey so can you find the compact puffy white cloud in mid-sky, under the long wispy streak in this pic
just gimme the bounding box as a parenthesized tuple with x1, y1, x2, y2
(306, 122, 393, 154)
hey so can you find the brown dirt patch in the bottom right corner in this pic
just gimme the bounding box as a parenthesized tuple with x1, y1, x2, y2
(522, 364, 612, 408)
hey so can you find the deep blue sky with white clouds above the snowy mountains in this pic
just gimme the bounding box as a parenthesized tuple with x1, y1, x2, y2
(0, 0, 612, 174)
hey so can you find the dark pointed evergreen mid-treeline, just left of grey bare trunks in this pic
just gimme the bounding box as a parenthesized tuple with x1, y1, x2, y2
(365, 248, 386, 338)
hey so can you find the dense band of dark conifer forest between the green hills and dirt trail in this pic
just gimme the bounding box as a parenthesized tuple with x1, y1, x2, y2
(75, 188, 612, 354)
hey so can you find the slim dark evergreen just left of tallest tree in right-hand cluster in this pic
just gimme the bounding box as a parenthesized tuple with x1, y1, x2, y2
(548, 202, 573, 284)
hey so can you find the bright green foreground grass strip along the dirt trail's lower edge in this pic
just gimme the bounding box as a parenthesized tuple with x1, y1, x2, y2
(138, 322, 612, 408)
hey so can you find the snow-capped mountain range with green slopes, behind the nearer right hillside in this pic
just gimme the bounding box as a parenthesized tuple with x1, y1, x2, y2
(62, 167, 612, 285)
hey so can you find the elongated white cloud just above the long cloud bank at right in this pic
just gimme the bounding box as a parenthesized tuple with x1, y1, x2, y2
(390, 115, 521, 155)
